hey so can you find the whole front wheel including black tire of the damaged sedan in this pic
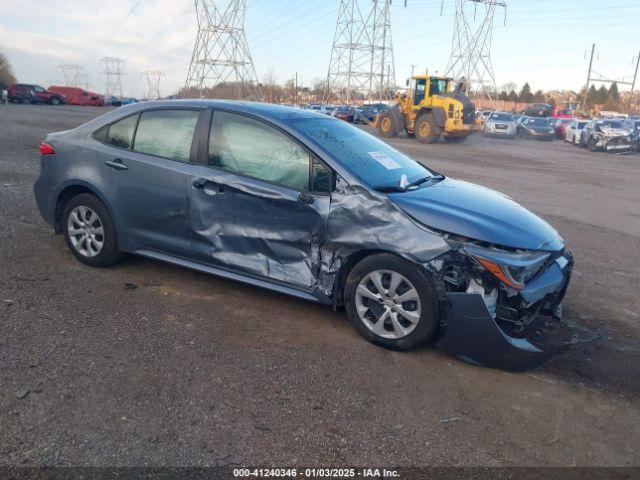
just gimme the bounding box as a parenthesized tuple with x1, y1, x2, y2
(344, 253, 440, 350)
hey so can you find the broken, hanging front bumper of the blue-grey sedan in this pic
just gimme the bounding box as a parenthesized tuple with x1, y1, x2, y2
(429, 248, 596, 371)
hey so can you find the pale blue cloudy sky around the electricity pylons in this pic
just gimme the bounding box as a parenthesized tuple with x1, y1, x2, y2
(0, 0, 640, 97)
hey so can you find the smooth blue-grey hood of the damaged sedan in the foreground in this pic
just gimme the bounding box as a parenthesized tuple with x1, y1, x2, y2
(389, 178, 564, 251)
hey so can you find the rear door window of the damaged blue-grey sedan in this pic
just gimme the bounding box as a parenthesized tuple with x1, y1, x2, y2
(133, 110, 199, 162)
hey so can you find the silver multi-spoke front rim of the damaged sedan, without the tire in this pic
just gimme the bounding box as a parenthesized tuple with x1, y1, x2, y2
(355, 270, 421, 339)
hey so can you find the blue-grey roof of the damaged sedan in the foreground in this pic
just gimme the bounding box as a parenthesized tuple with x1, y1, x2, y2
(121, 99, 326, 121)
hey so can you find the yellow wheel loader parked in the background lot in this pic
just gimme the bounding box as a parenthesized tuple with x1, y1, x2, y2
(376, 75, 475, 143)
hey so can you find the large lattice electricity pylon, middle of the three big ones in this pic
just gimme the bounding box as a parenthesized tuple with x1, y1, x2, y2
(326, 0, 395, 103)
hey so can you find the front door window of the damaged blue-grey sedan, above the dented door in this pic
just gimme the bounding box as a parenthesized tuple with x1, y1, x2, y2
(208, 112, 310, 190)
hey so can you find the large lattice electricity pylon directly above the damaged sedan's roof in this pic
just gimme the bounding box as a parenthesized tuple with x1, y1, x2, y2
(185, 0, 260, 98)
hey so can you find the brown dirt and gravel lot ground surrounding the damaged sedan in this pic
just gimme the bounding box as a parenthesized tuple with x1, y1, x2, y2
(0, 105, 640, 466)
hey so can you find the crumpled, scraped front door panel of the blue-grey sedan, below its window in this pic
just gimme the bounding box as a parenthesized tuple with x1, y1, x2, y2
(184, 167, 329, 289)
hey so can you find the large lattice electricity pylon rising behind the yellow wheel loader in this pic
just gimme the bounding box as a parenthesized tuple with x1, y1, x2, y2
(445, 0, 507, 104)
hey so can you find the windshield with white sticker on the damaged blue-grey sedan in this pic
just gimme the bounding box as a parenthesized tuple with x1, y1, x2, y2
(292, 118, 433, 188)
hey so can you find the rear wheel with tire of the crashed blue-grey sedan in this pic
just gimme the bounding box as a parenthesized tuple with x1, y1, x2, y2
(62, 193, 122, 267)
